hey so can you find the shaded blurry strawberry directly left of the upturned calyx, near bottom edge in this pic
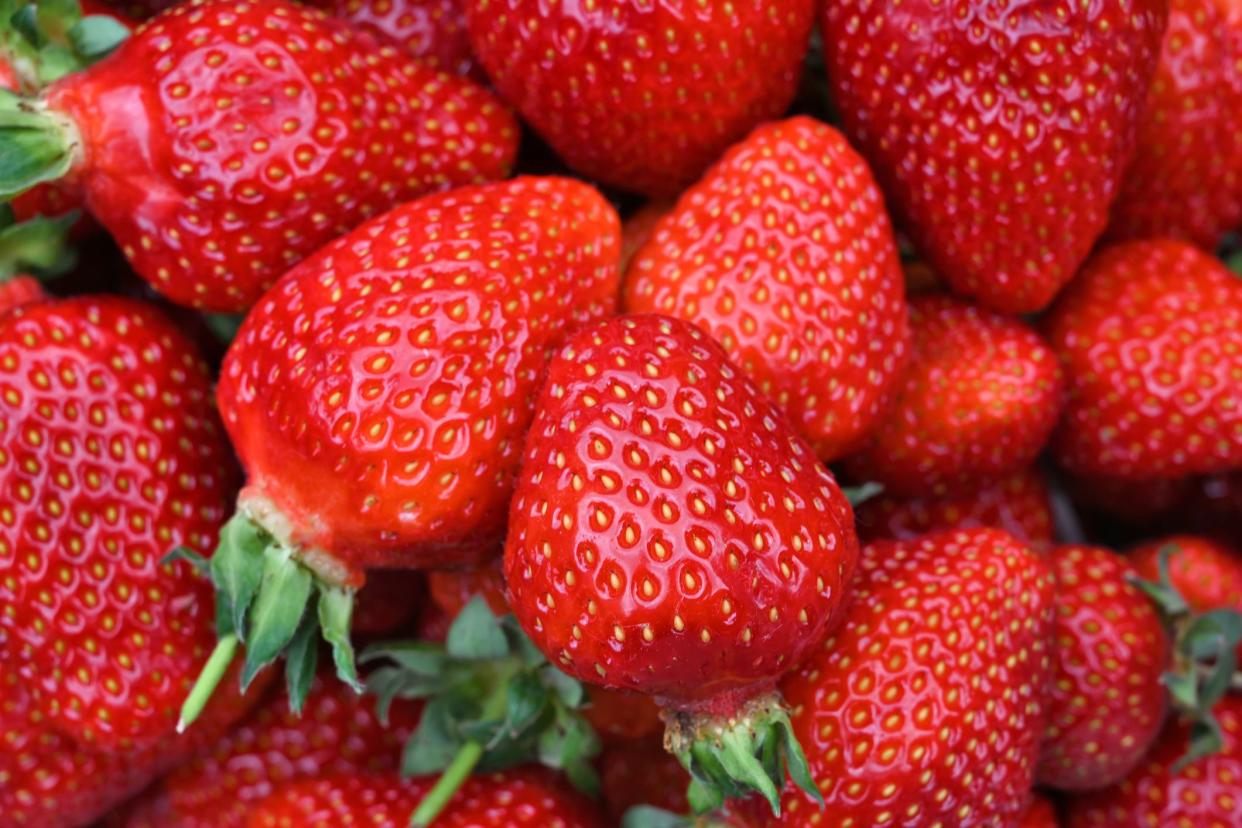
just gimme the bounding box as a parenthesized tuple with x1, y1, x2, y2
(118, 677, 422, 828)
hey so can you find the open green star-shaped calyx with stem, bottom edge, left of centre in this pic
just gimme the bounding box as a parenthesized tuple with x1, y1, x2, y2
(361, 597, 600, 826)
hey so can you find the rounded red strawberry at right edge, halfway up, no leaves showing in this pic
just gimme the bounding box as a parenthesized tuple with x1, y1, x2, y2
(1045, 241, 1242, 479)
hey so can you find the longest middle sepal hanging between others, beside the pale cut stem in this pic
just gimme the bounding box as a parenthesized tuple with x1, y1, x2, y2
(241, 544, 313, 689)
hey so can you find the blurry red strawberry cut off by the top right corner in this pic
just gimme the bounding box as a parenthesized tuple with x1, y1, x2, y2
(1109, 0, 1242, 251)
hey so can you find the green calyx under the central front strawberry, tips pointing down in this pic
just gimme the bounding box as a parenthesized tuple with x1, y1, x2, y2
(664, 691, 823, 816)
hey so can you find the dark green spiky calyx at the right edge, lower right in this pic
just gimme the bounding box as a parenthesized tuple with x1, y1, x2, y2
(1131, 544, 1242, 772)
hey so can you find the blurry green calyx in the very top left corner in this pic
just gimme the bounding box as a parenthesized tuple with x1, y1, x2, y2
(0, 0, 129, 94)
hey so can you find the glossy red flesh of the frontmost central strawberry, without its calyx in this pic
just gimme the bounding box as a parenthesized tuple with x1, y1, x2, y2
(504, 315, 857, 713)
